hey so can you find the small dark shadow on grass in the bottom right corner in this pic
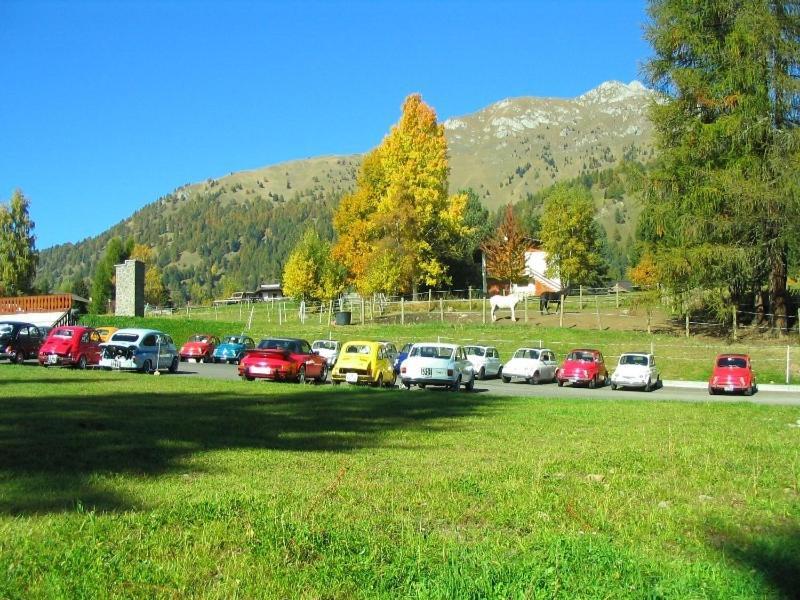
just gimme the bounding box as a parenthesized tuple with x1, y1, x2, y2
(711, 524, 800, 598)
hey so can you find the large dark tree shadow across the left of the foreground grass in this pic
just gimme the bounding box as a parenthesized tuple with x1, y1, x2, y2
(0, 386, 486, 514)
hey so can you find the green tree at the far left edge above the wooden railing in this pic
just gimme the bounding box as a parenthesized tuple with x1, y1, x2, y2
(0, 190, 39, 296)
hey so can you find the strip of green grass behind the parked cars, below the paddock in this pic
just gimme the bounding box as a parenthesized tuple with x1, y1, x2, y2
(82, 306, 800, 383)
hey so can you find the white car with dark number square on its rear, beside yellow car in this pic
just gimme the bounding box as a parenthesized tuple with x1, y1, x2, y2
(400, 342, 475, 391)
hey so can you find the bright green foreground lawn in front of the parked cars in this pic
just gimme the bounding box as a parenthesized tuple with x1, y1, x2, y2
(0, 364, 800, 599)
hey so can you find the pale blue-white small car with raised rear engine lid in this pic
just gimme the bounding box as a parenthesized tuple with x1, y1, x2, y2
(100, 329, 179, 373)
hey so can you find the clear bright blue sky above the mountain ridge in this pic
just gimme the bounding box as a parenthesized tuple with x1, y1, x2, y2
(0, 0, 649, 248)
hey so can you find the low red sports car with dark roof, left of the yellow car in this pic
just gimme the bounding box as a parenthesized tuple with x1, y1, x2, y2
(239, 338, 328, 383)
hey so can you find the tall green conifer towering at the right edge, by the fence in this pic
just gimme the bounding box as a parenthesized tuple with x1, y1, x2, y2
(639, 0, 800, 330)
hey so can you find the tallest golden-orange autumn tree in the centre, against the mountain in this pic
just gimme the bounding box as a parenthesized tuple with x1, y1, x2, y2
(333, 94, 469, 294)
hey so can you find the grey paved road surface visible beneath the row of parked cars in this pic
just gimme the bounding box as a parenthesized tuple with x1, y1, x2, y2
(180, 363, 800, 406)
